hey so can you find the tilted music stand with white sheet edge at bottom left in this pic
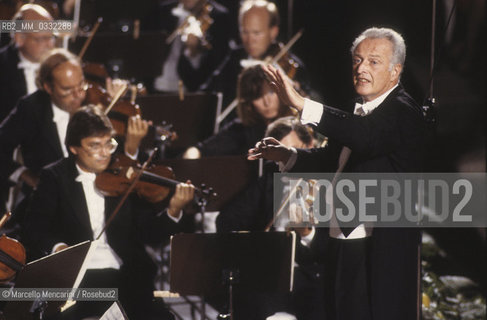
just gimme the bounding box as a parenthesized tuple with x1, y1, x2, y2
(4, 241, 95, 320)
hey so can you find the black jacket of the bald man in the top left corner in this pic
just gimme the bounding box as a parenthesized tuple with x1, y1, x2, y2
(0, 44, 27, 121)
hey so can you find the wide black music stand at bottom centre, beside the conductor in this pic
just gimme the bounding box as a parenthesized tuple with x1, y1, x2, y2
(170, 232, 296, 314)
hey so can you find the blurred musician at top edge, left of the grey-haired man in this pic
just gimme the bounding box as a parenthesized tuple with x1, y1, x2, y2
(142, 0, 229, 92)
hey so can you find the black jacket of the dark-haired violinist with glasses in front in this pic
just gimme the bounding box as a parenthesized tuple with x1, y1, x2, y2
(24, 157, 178, 294)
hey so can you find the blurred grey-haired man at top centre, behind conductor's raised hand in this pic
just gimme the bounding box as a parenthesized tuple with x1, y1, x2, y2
(201, 0, 309, 115)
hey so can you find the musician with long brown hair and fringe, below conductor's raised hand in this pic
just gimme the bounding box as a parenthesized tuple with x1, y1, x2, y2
(183, 66, 292, 159)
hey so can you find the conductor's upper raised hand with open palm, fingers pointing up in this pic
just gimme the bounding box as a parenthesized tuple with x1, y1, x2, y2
(262, 64, 304, 112)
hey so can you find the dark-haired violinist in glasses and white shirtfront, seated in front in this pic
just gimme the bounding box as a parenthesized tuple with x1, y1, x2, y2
(25, 105, 194, 319)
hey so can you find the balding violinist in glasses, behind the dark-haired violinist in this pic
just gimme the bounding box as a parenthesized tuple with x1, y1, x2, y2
(0, 49, 149, 225)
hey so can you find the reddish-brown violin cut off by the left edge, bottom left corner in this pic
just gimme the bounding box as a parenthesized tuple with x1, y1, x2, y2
(0, 212, 26, 283)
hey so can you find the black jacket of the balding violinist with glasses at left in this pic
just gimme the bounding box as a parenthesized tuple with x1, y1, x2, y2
(0, 90, 64, 185)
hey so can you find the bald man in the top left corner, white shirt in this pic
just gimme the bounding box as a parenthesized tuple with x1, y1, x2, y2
(0, 4, 54, 121)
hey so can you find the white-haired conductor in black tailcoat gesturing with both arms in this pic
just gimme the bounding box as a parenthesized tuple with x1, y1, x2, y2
(249, 28, 426, 320)
